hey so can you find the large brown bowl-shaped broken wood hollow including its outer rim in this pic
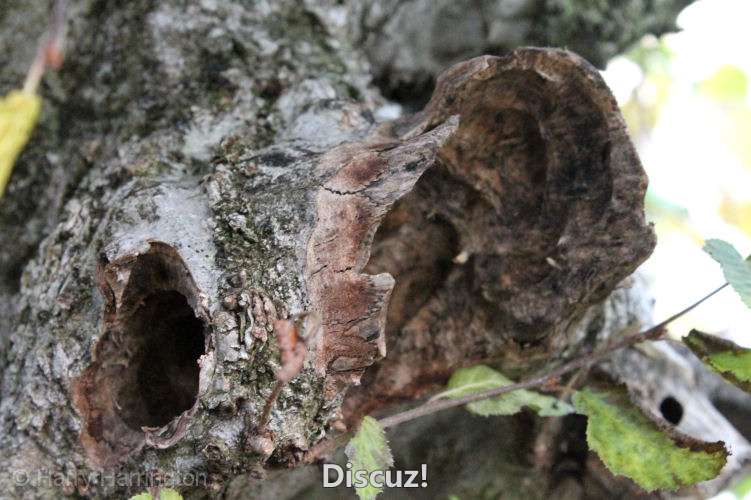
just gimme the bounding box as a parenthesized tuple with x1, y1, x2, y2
(344, 50, 655, 418)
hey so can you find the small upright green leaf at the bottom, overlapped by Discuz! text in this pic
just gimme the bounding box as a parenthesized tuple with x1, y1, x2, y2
(344, 417, 394, 500)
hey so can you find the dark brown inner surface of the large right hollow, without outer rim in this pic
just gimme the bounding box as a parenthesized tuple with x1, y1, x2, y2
(363, 70, 615, 406)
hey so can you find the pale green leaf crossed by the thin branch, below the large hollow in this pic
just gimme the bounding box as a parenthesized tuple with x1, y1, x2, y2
(436, 365, 574, 417)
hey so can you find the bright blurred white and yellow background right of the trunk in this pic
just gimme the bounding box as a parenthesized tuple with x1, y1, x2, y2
(603, 0, 751, 347)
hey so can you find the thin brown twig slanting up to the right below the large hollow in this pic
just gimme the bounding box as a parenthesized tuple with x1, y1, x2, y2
(379, 283, 728, 428)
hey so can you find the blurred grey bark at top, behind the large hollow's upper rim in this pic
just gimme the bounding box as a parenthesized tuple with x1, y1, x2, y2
(349, 0, 691, 106)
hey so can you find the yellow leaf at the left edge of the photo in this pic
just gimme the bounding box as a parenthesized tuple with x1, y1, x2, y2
(0, 90, 42, 197)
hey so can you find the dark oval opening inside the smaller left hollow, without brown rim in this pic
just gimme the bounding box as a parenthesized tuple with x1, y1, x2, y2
(114, 250, 205, 429)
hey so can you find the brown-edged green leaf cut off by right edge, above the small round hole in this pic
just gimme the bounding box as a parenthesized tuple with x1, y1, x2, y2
(683, 330, 751, 392)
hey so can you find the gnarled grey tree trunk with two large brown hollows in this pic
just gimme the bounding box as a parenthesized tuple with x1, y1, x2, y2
(0, 0, 747, 498)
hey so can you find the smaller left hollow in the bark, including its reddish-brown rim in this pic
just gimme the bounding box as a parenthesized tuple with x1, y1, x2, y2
(72, 242, 207, 466)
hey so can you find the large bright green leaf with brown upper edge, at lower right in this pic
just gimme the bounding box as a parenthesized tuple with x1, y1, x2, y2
(573, 389, 728, 491)
